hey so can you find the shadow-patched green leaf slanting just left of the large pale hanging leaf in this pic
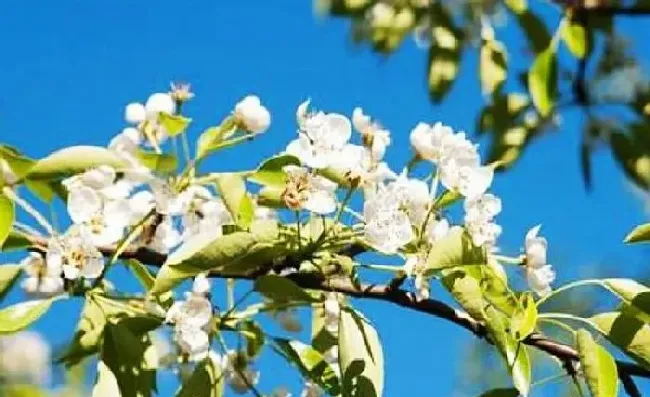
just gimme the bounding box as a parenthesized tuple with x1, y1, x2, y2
(273, 338, 341, 396)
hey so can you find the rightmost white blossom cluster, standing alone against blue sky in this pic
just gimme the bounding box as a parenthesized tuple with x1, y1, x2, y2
(525, 225, 555, 296)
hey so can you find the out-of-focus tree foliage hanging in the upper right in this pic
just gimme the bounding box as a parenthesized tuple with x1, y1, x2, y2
(315, 0, 650, 189)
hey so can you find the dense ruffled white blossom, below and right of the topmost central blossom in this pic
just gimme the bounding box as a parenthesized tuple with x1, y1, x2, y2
(363, 185, 414, 254)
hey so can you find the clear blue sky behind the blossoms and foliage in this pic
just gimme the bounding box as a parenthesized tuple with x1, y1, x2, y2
(0, 0, 650, 397)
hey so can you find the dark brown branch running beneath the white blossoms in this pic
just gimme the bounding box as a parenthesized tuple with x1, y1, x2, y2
(22, 236, 650, 378)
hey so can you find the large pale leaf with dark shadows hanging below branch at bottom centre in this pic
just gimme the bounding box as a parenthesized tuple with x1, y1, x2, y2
(339, 309, 384, 397)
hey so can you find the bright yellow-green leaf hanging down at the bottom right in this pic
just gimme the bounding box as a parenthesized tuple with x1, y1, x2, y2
(577, 329, 618, 397)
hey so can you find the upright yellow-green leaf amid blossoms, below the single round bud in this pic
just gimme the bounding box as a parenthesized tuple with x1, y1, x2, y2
(217, 173, 254, 229)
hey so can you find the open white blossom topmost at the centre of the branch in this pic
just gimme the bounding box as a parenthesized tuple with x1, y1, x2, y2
(286, 100, 352, 169)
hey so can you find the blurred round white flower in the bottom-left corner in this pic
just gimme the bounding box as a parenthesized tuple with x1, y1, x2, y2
(0, 331, 52, 384)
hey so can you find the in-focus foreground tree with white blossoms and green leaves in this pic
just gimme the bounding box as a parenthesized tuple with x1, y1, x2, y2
(0, 84, 650, 397)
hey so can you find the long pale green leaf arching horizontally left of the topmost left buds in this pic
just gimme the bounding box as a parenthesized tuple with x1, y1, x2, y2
(27, 146, 127, 179)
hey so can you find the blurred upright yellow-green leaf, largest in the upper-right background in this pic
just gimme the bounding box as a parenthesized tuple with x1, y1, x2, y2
(528, 44, 557, 117)
